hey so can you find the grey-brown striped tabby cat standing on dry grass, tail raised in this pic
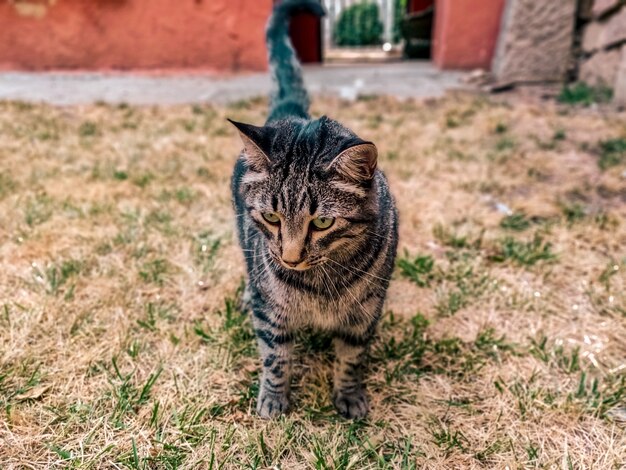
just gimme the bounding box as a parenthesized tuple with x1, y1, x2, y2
(230, 0, 398, 419)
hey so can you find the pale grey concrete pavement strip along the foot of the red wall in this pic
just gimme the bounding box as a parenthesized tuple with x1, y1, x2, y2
(0, 61, 463, 105)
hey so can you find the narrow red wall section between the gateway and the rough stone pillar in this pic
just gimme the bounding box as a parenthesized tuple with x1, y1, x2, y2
(433, 0, 504, 70)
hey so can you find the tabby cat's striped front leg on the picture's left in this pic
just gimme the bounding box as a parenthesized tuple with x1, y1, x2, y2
(254, 311, 292, 419)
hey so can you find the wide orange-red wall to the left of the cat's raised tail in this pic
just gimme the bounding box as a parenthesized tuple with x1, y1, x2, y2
(0, 0, 272, 71)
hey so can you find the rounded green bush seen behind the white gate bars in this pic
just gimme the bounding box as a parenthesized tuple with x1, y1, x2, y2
(335, 2, 383, 46)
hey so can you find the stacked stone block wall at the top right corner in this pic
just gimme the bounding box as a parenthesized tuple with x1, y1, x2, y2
(578, 0, 626, 105)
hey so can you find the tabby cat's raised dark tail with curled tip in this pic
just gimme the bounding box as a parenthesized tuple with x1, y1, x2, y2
(266, 0, 324, 122)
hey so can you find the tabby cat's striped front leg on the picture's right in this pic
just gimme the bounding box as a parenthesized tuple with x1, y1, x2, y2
(333, 337, 369, 419)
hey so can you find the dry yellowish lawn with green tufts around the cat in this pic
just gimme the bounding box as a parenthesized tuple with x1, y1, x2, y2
(0, 94, 626, 469)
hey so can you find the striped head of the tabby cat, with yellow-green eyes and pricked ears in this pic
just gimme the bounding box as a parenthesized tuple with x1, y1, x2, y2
(231, 117, 378, 271)
